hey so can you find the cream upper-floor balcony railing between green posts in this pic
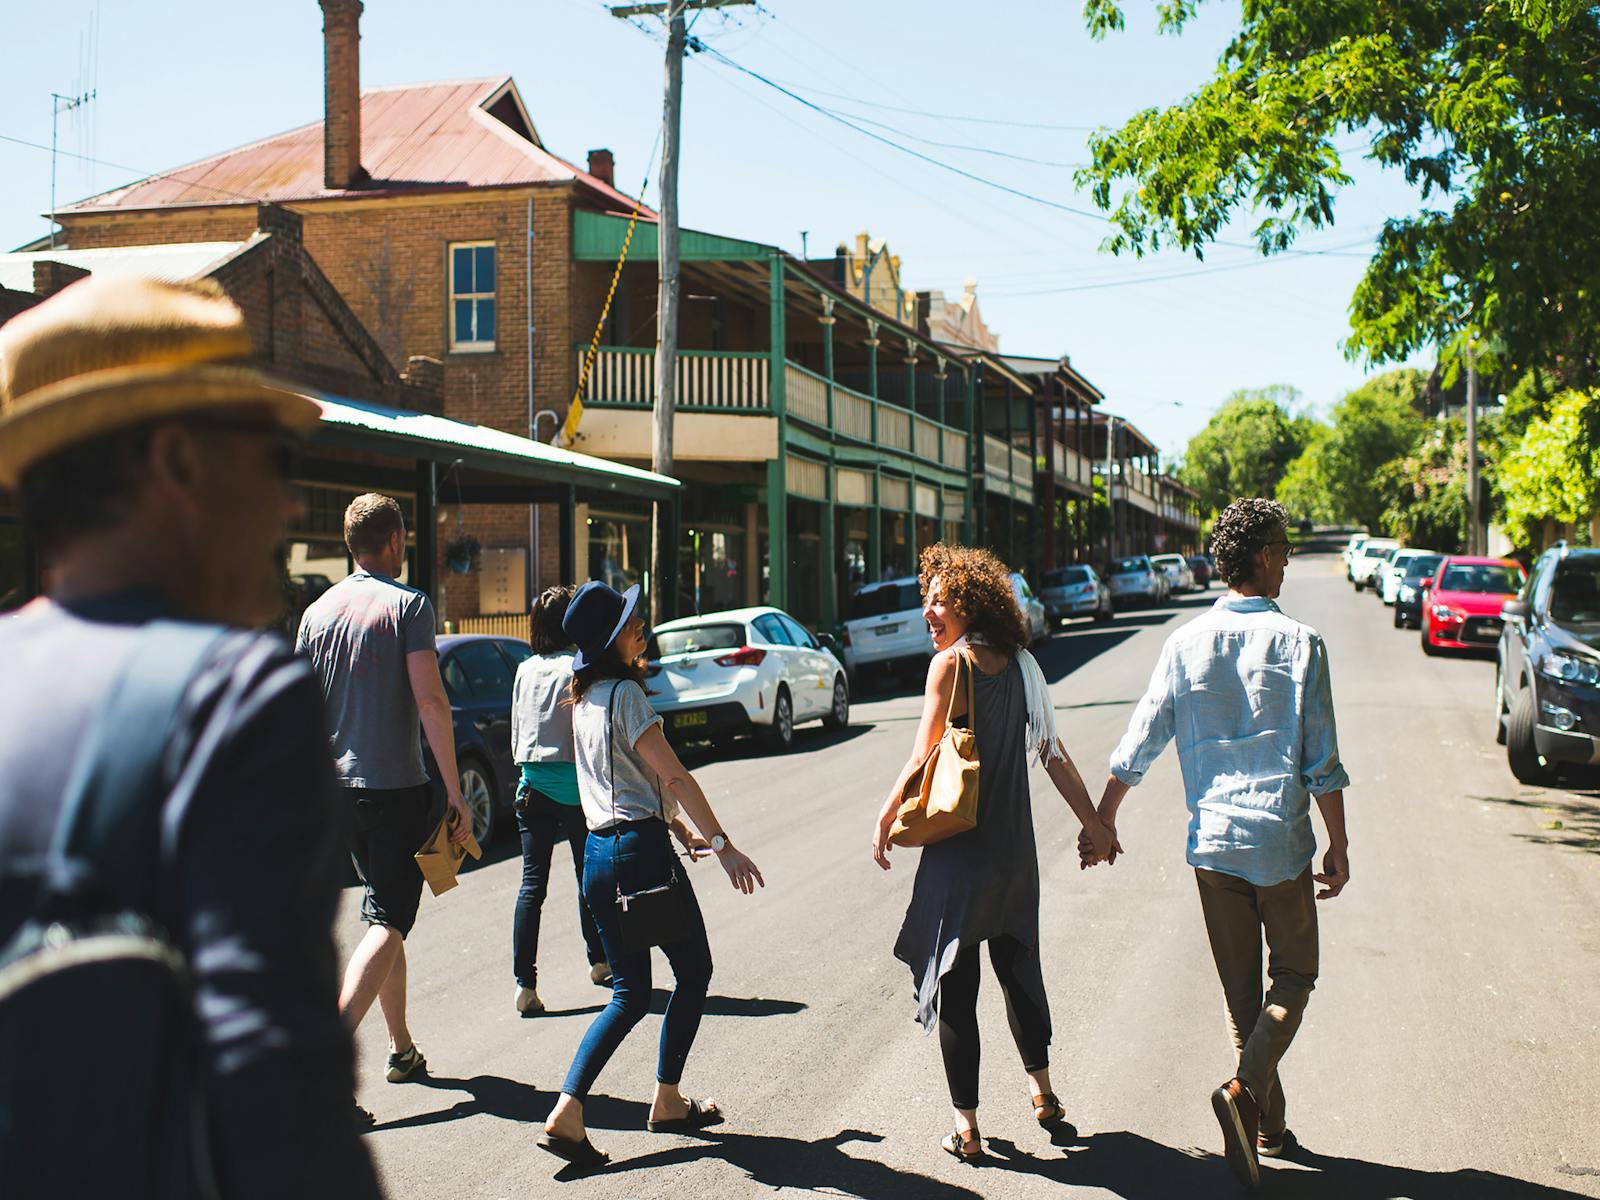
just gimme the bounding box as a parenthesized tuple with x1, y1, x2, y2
(578, 346, 968, 475)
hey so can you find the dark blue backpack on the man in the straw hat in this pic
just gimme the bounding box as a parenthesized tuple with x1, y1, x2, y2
(0, 621, 226, 1200)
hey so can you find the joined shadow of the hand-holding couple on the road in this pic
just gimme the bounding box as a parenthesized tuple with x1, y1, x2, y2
(984, 1131, 1581, 1200)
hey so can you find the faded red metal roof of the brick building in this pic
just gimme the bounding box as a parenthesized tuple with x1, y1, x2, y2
(61, 77, 654, 218)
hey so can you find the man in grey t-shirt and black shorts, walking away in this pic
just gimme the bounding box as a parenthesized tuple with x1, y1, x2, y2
(294, 493, 472, 1120)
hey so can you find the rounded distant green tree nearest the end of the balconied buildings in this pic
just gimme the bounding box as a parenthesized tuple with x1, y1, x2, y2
(1178, 384, 1307, 514)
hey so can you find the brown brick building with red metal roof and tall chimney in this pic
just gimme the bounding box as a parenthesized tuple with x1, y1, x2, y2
(56, 0, 653, 618)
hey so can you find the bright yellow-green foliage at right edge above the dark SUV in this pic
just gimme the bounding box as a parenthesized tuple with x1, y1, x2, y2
(1496, 392, 1600, 546)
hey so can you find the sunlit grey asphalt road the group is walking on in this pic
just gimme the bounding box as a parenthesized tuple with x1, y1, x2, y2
(339, 555, 1600, 1200)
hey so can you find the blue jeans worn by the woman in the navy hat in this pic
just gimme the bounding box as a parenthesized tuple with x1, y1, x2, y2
(562, 818, 710, 1102)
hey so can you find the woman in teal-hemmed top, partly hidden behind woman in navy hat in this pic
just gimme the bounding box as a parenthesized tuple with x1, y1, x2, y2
(510, 587, 611, 1016)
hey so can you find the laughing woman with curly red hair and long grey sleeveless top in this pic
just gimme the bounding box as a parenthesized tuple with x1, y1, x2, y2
(872, 542, 1115, 1162)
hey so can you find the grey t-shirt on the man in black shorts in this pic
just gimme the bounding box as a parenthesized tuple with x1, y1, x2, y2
(294, 571, 434, 789)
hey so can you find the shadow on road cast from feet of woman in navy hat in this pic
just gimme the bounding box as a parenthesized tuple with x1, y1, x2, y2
(569, 1132, 997, 1200)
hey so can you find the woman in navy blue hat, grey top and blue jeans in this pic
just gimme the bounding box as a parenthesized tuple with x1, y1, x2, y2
(539, 581, 765, 1166)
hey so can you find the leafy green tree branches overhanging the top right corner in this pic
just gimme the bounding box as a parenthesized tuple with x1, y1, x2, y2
(1078, 0, 1600, 386)
